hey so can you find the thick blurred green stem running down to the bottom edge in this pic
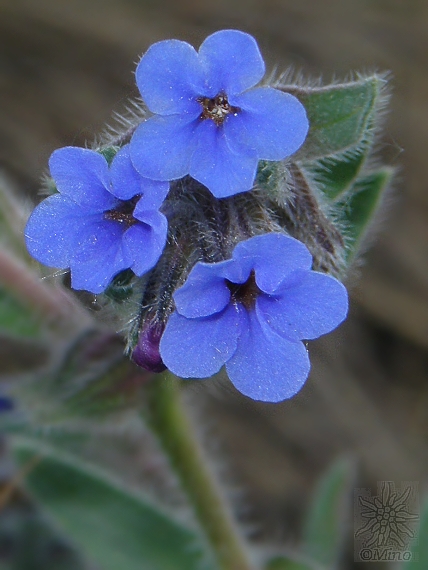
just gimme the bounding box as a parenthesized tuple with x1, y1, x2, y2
(146, 372, 254, 570)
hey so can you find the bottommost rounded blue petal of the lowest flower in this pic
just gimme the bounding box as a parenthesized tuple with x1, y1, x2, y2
(226, 311, 310, 402)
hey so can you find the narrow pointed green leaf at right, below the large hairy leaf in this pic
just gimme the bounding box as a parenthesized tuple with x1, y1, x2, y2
(343, 167, 394, 261)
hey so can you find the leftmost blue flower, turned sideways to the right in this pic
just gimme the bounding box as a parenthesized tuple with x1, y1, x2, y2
(25, 145, 169, 293)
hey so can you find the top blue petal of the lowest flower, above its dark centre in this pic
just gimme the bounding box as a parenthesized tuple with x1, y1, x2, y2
(233, 233, 312, 293)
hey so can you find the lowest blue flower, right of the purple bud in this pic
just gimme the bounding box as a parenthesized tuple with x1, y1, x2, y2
(160, 233, 348, 402)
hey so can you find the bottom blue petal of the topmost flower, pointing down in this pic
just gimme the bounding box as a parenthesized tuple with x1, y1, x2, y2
(189, 120, 258, 198)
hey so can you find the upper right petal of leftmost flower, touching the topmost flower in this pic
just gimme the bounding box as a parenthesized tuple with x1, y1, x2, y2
(110, 145, 169, 210)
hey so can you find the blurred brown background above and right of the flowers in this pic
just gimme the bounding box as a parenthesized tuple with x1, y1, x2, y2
(0, 0, 428, 568)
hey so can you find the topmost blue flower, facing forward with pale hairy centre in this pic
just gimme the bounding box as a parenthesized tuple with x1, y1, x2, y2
(131, 30, 308, 198)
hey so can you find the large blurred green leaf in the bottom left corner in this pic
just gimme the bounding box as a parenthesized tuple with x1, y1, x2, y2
(12, 438, 213, 570)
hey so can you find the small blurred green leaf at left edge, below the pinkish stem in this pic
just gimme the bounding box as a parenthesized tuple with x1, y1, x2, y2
(0, 286, 41, 338)
